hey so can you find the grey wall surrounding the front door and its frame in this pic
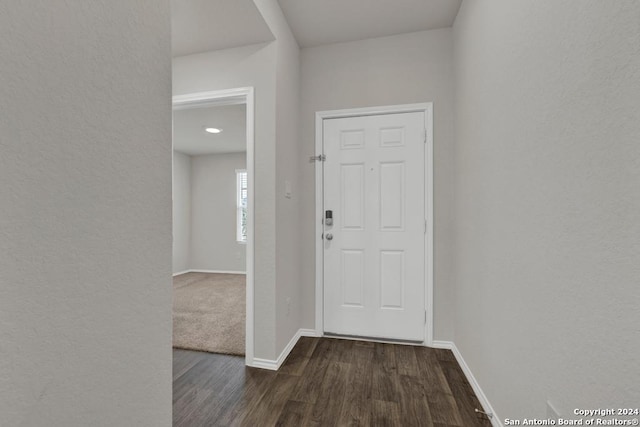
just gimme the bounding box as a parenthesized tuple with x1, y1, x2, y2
(298, 29, 454, 340)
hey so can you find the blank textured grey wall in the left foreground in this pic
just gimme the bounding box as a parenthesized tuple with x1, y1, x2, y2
(0, 0, 171, 427)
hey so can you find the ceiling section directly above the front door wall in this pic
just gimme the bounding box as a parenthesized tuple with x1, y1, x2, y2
(278, 0, 462, 47)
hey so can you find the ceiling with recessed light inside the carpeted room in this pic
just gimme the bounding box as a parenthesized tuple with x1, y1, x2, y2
(173, 104, 247, 156)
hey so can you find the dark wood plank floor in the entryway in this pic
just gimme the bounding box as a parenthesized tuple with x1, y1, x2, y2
(173, 337, 491, 427)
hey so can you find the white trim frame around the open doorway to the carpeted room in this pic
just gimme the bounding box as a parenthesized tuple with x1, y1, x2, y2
(173, 87, 255, 366)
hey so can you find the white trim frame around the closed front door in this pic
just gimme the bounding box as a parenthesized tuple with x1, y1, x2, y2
(315, 102, 433, 346)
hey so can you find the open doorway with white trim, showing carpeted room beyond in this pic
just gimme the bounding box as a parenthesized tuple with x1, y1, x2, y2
(173, 87, 254, 365)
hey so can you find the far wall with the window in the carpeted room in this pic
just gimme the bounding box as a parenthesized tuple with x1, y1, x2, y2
(189, 153, 247, 271)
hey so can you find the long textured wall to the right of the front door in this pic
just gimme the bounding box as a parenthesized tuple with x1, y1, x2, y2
(454, 0, 640, 418)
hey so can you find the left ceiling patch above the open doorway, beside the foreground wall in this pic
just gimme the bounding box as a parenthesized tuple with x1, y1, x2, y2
(171, 0, 274, 57)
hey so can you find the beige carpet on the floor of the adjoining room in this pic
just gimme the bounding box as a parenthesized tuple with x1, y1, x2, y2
(173, 273, 246, 355)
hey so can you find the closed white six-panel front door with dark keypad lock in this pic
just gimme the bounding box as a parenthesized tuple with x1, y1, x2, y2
(323, 112, 426, 341)
